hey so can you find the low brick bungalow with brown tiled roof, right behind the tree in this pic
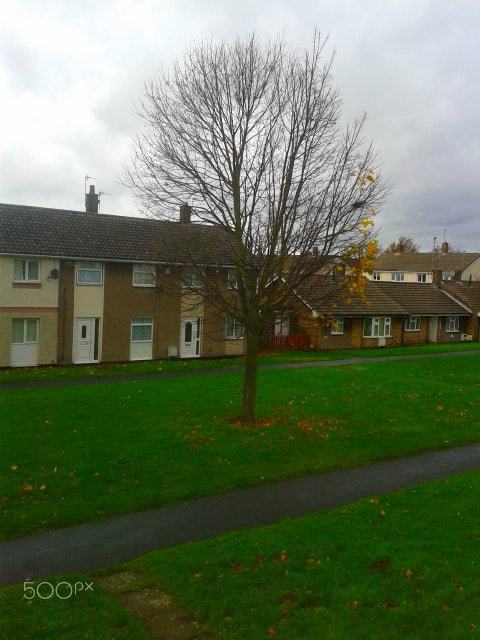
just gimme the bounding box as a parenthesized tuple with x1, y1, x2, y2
(295, 276, 472, 349)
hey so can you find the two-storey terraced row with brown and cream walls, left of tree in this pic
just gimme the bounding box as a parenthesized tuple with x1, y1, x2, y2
(0, 188, 244, 366)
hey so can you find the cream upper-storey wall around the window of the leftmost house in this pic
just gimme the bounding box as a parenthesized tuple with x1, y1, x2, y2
(0, 256, 58, 308)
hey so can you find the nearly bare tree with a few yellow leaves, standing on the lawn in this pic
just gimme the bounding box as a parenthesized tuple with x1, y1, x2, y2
(125, 31, 387, 420)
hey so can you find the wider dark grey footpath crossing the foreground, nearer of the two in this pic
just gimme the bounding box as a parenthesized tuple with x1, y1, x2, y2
(0, 442, 480, 587)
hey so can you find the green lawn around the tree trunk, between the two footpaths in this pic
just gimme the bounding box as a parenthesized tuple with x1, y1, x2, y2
(0, 354, 480, 539)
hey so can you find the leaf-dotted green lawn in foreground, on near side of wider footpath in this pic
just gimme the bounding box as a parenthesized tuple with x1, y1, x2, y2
(0, 472, 480, 640)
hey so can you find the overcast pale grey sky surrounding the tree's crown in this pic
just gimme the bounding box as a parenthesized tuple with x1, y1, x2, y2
(0, 0, 480, 252)
